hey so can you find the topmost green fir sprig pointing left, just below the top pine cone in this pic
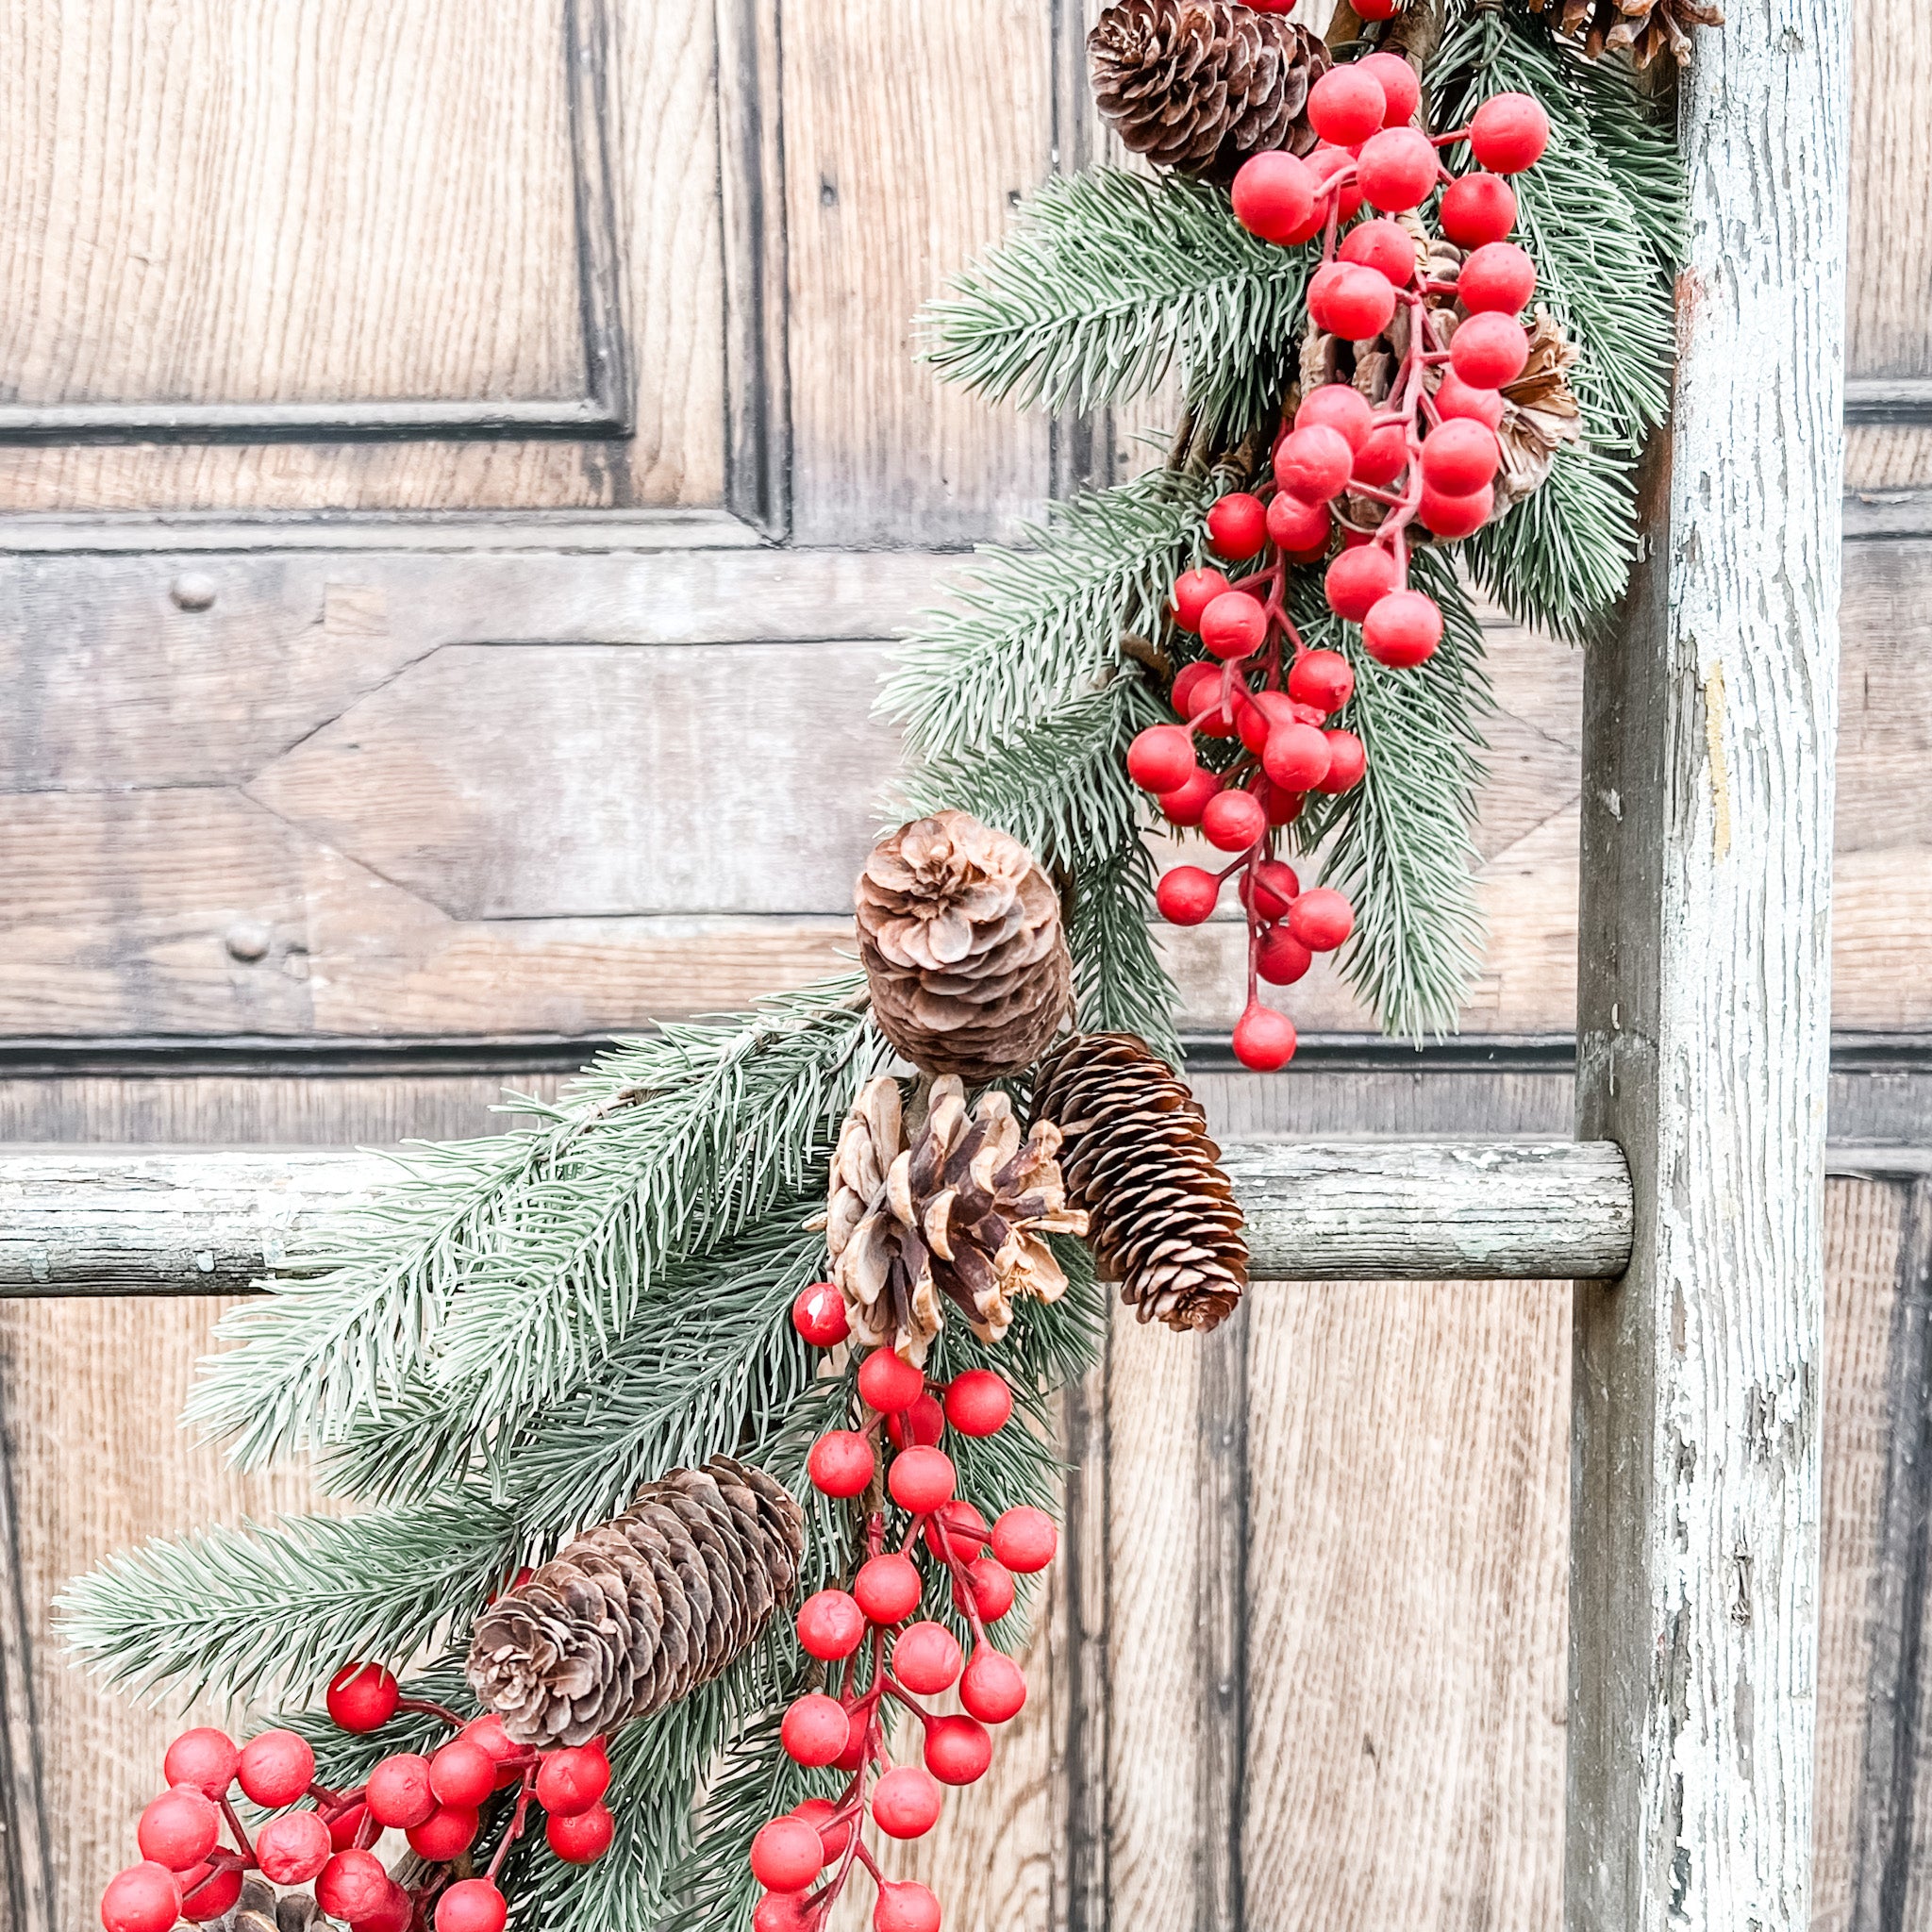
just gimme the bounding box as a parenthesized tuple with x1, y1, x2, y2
(922, 168, 1312, 433)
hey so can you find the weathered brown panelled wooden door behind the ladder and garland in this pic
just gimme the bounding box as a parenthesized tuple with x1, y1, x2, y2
(0, 0, 1932, 1932)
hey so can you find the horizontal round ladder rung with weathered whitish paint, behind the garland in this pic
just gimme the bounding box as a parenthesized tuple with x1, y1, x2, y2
(0, 1140, 1631, 1296)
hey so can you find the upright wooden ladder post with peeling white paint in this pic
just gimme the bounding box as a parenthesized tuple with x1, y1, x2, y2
(1565, 0, 1851, 1932)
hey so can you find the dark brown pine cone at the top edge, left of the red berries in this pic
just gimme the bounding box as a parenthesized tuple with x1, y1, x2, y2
(1088, 0, 1329, 179)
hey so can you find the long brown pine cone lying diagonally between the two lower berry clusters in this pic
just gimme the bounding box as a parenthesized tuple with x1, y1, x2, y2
(468, 1455, 806, 1744)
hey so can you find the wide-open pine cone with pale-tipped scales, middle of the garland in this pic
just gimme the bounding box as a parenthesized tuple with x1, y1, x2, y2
(824, 1078, 1086, 1364)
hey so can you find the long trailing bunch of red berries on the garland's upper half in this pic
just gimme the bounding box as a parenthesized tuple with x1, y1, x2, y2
(1126, 60, 1549, 1071)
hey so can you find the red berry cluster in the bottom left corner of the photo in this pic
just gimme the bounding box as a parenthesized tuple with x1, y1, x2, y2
(100, 1663, 612, 1932)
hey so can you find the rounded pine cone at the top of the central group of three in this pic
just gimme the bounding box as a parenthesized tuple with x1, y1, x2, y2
(852, 811, 1074, 1086)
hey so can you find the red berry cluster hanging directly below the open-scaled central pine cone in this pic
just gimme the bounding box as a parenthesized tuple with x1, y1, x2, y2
(769, 1283, 1057, 1932)
